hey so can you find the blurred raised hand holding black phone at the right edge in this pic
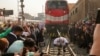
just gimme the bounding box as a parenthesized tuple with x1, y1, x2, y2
(90, 8, 100, 56)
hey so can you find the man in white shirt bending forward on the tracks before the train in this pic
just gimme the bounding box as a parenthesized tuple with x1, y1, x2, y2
(53, 32, 69, 55)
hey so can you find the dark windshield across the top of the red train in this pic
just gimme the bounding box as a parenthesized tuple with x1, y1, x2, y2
(47, 1, 67, 9)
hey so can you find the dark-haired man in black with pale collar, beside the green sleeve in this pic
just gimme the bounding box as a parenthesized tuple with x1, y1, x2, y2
(6, 26, 23, 51)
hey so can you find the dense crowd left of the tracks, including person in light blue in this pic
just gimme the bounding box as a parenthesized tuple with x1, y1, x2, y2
(0, 22, 48, 56)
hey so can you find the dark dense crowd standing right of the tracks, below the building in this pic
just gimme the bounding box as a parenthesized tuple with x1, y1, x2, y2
(69, 19, 95, 53)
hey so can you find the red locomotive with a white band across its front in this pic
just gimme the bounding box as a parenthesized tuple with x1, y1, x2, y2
(45, 0, 69, 36)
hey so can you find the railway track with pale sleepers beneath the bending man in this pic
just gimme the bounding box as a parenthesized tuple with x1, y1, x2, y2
(43, 31, 77, 56)
